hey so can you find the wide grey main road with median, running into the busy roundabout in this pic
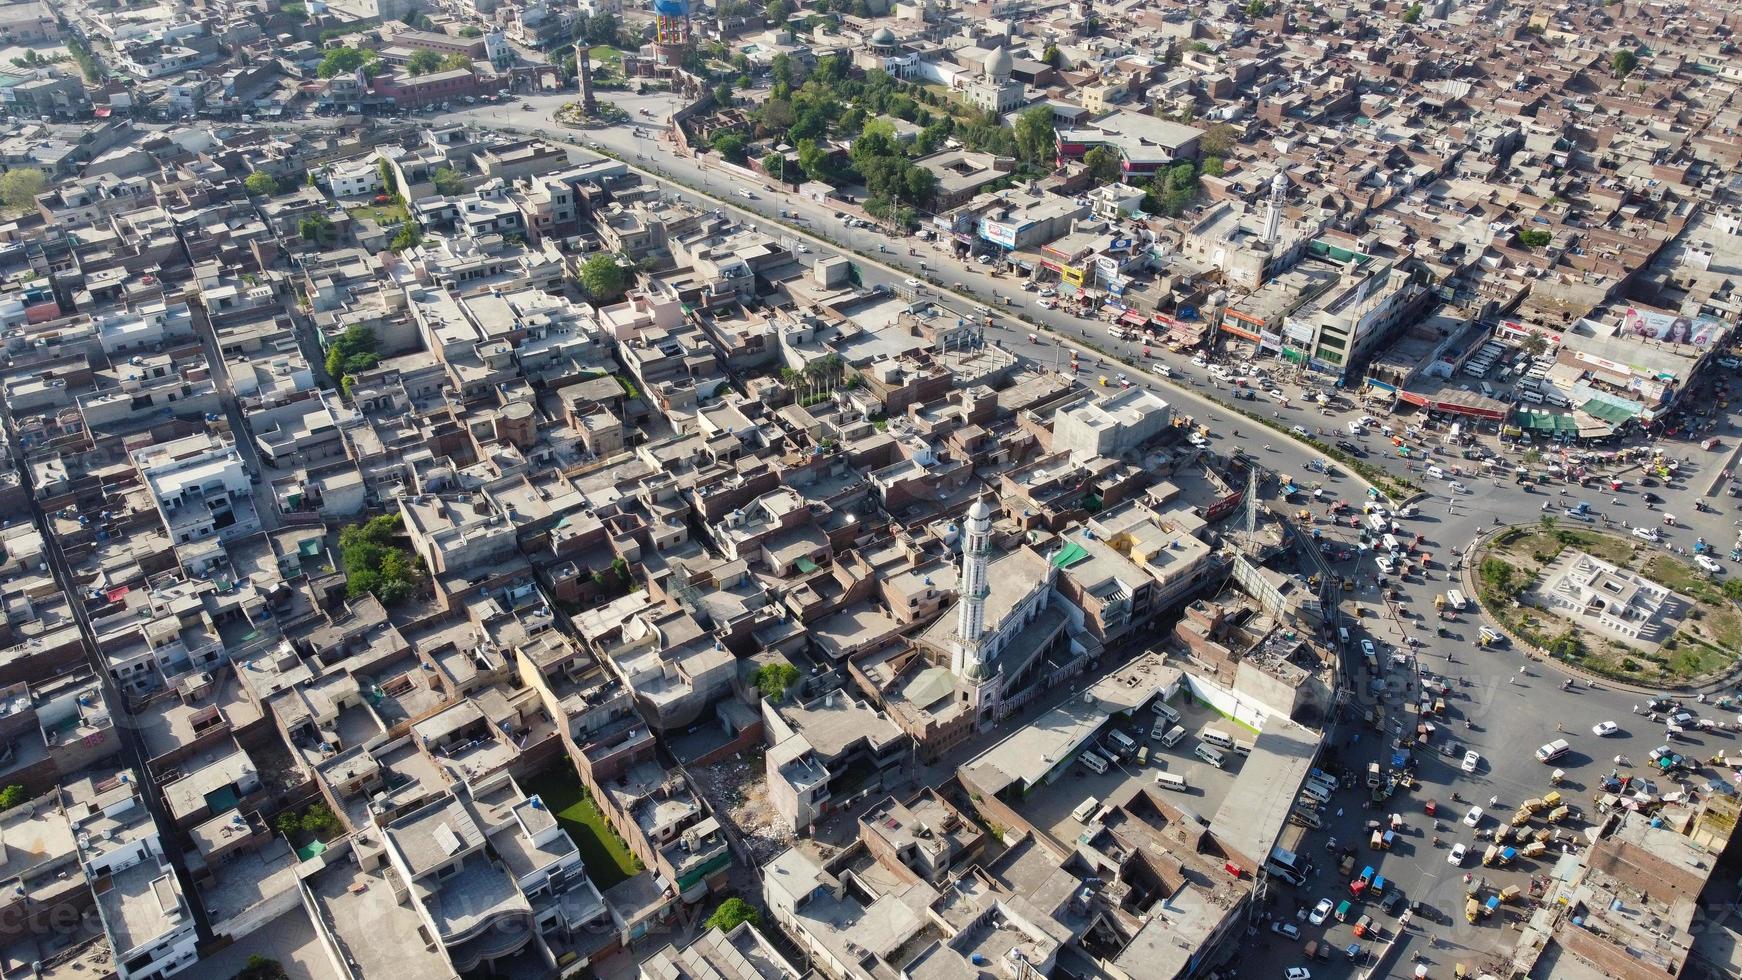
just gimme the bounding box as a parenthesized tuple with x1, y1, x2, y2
(453, 96, 1742, 977)
